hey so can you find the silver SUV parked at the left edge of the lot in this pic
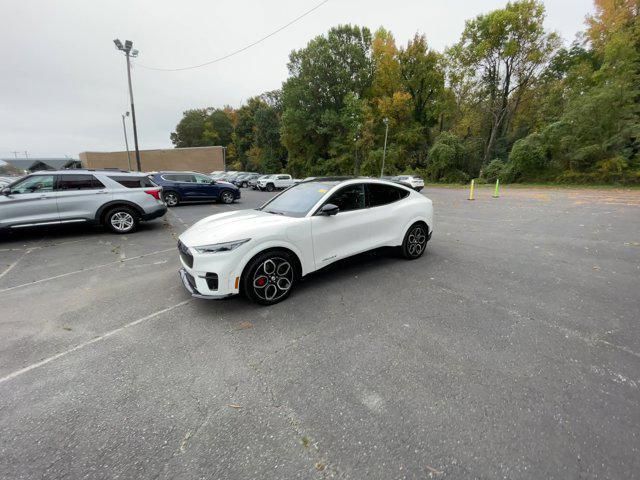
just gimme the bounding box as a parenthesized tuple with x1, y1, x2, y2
(0, 169, 167, 233)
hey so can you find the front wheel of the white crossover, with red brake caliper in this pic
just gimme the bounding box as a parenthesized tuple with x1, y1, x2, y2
(240, 250, 299, 305)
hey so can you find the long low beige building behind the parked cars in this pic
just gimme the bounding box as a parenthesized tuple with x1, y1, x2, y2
(80, 147, 225, 173)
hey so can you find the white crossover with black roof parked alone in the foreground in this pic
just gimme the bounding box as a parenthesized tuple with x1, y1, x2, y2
(178, 177, 433, 305)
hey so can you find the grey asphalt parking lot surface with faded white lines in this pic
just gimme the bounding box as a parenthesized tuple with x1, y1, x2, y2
(0, 188, 640, 479)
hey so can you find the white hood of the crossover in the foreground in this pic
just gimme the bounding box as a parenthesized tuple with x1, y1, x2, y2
(180, 210, 293, 247)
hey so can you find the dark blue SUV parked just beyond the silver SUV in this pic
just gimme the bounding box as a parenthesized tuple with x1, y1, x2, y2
(149, 172, 240, 207)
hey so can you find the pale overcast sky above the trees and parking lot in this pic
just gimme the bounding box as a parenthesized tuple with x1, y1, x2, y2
(0, 0, 593, 157)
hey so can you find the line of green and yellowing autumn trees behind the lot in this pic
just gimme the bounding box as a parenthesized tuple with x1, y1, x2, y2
(171, 0, 640, 184)
